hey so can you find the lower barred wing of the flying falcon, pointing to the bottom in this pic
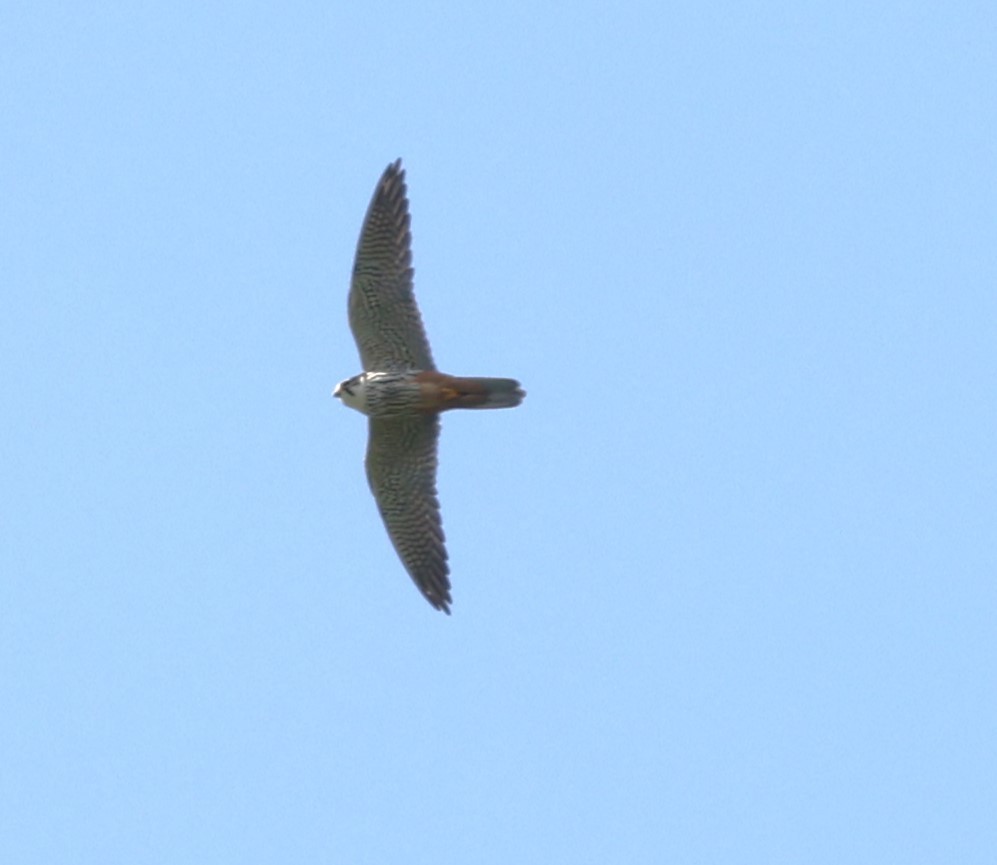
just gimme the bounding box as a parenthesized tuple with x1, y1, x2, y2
(367, 414, 451, 614)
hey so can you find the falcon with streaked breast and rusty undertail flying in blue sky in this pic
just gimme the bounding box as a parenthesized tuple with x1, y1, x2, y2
(333, 159, 526, 615)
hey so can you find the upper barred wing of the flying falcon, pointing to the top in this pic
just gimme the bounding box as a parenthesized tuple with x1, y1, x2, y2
(349, 159, 436, 371)
